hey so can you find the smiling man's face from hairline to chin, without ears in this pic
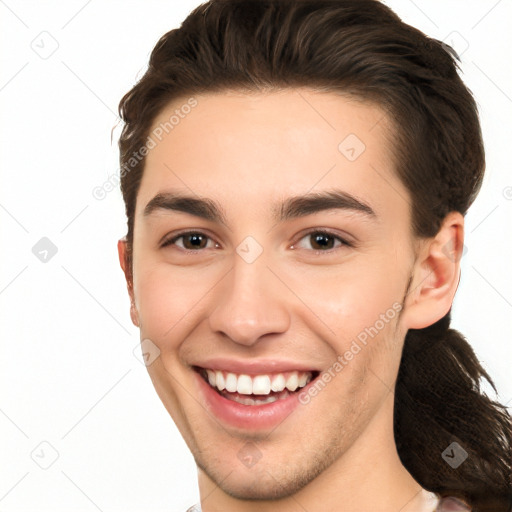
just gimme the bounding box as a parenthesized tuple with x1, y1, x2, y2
(126, 89, 414, 499)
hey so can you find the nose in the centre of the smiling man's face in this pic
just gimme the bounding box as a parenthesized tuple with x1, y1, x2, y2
(209, 255, 290, 346)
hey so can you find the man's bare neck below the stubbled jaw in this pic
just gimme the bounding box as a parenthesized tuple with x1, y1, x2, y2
(195, 393, 437, 512)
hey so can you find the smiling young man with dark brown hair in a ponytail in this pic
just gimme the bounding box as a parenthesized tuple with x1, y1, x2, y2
(118, 0, 511, 512)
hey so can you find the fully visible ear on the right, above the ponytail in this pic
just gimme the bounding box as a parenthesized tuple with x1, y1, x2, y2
(403, 212, 464, 329)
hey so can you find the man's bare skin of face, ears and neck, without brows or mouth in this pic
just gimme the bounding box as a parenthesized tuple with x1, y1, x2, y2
(118, 88, 464, 512)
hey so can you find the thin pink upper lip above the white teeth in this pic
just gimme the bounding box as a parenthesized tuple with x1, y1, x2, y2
(194, 358, 319, 375)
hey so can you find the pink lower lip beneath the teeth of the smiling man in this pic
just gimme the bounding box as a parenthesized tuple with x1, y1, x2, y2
(194, 372, 311, 430)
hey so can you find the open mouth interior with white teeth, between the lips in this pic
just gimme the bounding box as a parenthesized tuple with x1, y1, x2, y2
(194, 367, 320, 406)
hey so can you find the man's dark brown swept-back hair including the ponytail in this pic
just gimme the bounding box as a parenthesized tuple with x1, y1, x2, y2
(119, 0, 512, 512)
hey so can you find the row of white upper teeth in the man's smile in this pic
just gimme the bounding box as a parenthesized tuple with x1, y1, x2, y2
(206, 370, 312, 395)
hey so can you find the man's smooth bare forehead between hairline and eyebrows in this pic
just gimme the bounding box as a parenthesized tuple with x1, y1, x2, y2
(137, 89, 408, 222)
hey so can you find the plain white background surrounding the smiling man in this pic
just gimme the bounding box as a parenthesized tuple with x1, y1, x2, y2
(0, 0, 512, 512)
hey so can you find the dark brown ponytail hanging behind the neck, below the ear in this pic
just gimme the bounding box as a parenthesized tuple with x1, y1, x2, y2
(394, 312, 512, 512)
